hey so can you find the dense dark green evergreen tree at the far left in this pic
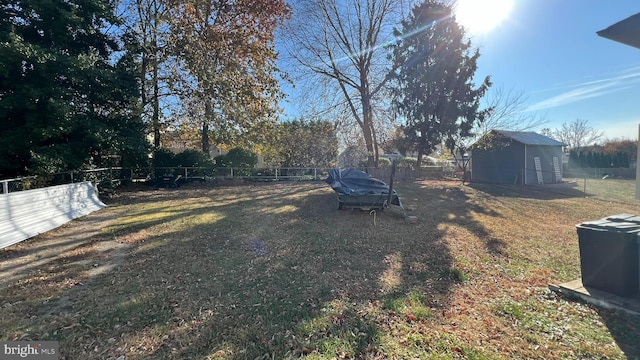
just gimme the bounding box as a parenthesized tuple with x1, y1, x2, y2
(0, 0, 145, 177)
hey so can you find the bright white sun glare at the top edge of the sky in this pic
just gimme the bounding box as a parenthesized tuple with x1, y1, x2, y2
(455, 0, 513, 34)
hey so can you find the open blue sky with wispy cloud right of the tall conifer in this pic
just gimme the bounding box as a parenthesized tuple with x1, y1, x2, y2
(472, 0, 640, 140)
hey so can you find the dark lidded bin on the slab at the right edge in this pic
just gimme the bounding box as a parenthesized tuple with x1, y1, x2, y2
(576, 214, 640, 297)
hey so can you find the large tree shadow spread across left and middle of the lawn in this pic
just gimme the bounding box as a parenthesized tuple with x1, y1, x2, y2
(2, 183, 502, 359)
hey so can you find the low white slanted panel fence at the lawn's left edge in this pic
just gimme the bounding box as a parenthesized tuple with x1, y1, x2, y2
(0, 181, 106, 249)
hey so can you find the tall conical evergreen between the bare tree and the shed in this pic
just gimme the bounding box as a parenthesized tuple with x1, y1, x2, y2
(393, 0, 491, 166)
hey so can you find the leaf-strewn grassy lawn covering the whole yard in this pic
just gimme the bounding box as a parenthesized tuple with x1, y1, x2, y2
(0, 181, 640, 360)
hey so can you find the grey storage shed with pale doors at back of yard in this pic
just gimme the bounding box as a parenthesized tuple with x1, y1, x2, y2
(471, 130, 566, 185)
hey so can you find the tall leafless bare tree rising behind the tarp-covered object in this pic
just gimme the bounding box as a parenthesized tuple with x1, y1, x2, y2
(287, 0, 403, 166)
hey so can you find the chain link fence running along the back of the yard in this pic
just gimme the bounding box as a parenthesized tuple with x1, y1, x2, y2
(7, 166, 640, 205)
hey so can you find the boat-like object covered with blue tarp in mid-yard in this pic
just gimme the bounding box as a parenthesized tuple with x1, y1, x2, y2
(326, 168, 402, 209)
